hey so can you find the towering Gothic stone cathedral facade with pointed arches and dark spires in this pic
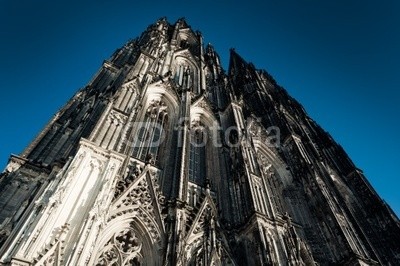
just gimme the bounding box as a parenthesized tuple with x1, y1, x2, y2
(0, 18, 400, 266)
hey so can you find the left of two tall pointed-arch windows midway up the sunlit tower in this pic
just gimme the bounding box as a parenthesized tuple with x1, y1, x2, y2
(132, 101, 168, 162)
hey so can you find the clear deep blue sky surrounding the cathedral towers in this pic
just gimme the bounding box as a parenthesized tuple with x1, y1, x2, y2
(0, 0, 400, 215)
